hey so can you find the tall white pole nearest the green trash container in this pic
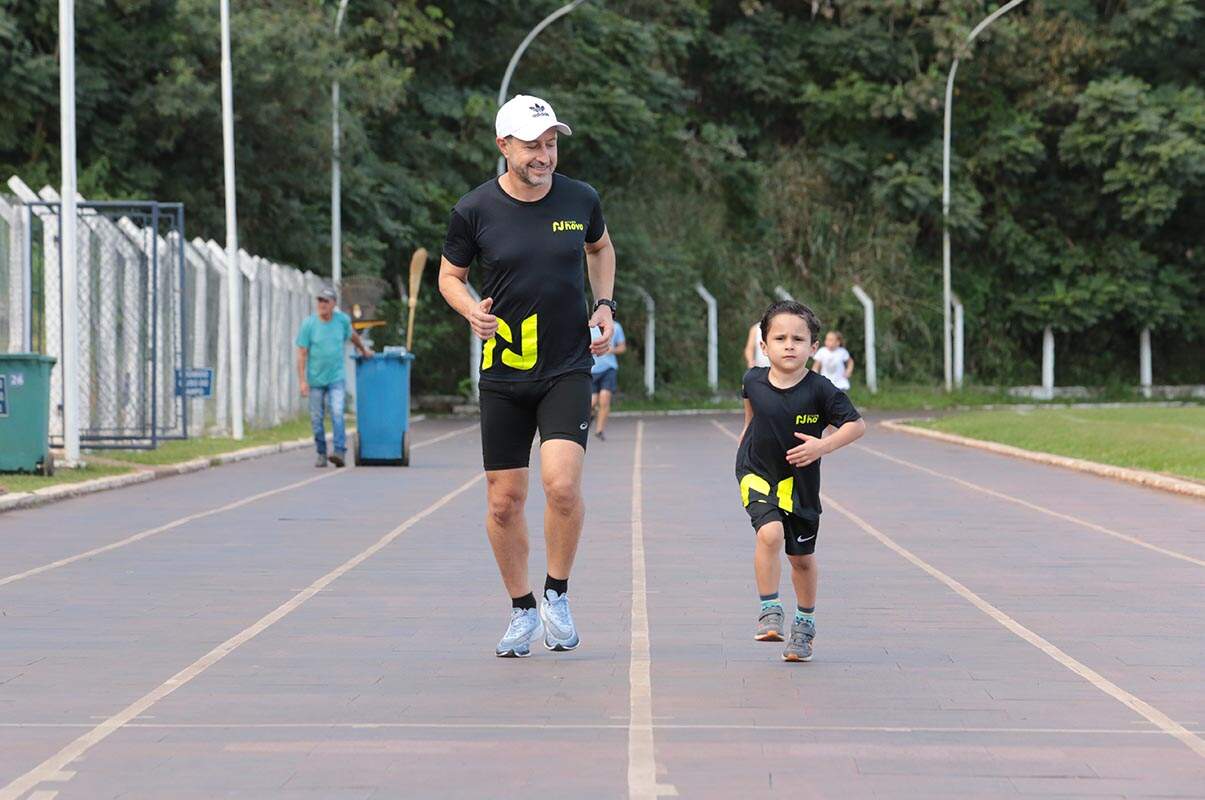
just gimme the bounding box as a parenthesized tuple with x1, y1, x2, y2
(59, 0, 80, 465)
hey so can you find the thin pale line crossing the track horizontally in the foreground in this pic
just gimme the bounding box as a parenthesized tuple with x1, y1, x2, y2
(0, 720, 1205, 736)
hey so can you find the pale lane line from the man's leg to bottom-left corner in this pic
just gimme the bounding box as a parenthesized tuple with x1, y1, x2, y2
(0, 472, 486, 800)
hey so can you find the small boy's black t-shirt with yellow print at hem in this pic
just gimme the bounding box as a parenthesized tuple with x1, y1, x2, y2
(736, 366, 862, 520)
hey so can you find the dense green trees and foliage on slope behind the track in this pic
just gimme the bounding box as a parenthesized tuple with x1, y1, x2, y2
(0, 0, 1205, 392)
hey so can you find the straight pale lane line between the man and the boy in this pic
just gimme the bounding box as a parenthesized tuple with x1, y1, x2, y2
(627, 419, 677, 800)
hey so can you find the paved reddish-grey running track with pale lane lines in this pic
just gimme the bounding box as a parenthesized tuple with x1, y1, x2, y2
(0, 414, 1205, 800)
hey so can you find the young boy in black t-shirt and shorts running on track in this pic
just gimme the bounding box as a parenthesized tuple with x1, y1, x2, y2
(736, 300, 866, 661)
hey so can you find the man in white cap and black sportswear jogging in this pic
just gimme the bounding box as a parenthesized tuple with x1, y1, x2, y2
(440, 95, 615, 658)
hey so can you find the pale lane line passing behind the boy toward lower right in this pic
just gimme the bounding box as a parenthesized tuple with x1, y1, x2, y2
(712, 420, 1205, 758)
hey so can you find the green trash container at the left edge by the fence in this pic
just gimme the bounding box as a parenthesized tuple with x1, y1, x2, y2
(0, 353, 54, 475)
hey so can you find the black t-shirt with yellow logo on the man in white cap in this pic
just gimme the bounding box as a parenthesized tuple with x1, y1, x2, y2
(443, 173, 606, 381)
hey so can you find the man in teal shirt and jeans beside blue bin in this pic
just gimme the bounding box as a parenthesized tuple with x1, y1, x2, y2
(296, 287, 372, 466)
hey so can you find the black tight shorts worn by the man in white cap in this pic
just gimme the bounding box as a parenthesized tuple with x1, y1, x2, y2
(480, 372, 590, 471)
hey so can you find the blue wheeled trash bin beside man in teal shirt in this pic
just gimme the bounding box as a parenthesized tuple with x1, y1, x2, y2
(353, 353, 415, 466)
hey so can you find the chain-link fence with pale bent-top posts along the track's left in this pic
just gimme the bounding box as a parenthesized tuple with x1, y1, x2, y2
(0, 178, 322, 446)
